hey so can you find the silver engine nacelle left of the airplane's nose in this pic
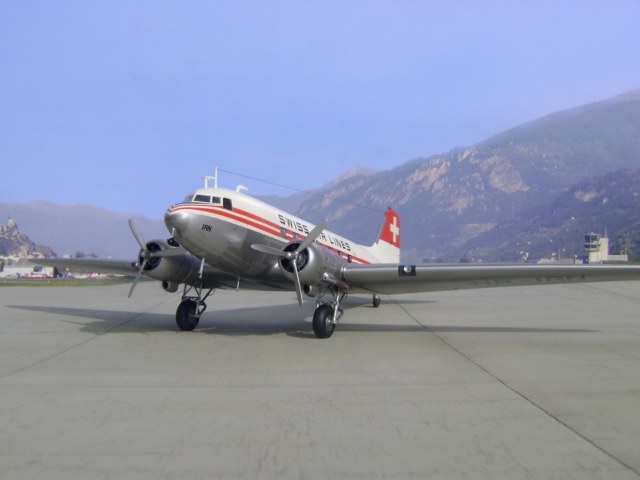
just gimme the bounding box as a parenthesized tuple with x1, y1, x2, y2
(138, 240, 200, 284)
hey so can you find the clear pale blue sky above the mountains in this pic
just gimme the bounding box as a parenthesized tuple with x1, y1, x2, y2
(0, 0, 640, 217)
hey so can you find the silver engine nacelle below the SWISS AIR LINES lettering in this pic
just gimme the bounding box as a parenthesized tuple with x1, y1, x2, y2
(279, 242, 347, 290)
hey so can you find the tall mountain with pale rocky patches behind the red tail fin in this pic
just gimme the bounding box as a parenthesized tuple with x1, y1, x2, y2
(288, 90, 640, 261)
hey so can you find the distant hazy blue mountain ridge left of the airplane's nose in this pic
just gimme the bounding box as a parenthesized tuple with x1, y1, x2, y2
(0, 201, 169, 259)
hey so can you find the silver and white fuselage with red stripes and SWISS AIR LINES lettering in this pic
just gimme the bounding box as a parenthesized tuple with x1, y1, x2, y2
(164, 188, 377, 289)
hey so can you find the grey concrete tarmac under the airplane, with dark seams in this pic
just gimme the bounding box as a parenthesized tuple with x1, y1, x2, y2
(0, 282, 640, 480)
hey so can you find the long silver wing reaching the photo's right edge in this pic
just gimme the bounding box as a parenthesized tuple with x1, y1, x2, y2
(342, 264, 640, 294)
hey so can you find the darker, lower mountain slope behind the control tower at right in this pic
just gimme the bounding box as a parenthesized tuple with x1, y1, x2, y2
(457, 169, 640, 262)
